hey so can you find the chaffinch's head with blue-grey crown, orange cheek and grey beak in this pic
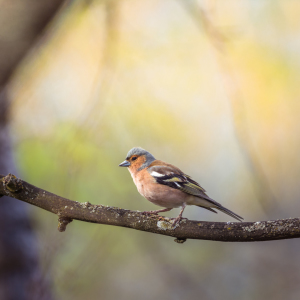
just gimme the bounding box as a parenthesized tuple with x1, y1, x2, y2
(119, 147, 155, 172)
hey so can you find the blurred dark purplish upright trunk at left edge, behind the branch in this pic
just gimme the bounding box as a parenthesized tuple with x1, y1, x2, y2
(0, 91, 47, 299)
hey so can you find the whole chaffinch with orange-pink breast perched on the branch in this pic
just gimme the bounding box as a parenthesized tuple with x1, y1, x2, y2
(119, 147, 243, 227)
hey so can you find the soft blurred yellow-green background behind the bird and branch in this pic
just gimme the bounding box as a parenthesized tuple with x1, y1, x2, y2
(0, 0, 300, 300)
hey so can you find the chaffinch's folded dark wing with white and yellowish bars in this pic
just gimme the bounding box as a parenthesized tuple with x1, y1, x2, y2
(148, 161, 214, 202)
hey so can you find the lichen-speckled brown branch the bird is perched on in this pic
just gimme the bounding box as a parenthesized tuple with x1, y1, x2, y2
(0, 174, 300, 243)
